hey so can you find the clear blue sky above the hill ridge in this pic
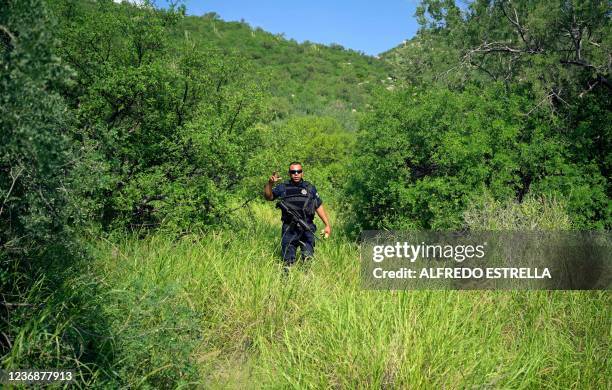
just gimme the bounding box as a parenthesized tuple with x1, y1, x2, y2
(170, 0, 418, 55)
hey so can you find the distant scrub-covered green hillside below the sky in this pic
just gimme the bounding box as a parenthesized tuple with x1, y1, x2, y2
(174, 13, 391, 115)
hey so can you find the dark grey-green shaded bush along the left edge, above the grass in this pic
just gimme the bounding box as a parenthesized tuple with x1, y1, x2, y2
(0, 1, 71, 266)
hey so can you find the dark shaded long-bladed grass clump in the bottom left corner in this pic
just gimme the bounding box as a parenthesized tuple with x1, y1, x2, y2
(0, 261, 116, 387)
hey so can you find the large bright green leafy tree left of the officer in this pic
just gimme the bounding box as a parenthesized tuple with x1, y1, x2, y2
(53, 0, 269, 232)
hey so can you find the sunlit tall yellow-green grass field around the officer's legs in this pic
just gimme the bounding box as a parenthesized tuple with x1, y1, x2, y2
(79, 204, 612, 389)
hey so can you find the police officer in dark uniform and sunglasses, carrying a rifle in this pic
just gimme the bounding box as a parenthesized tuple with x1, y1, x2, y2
(264, 161, 331, 266)
